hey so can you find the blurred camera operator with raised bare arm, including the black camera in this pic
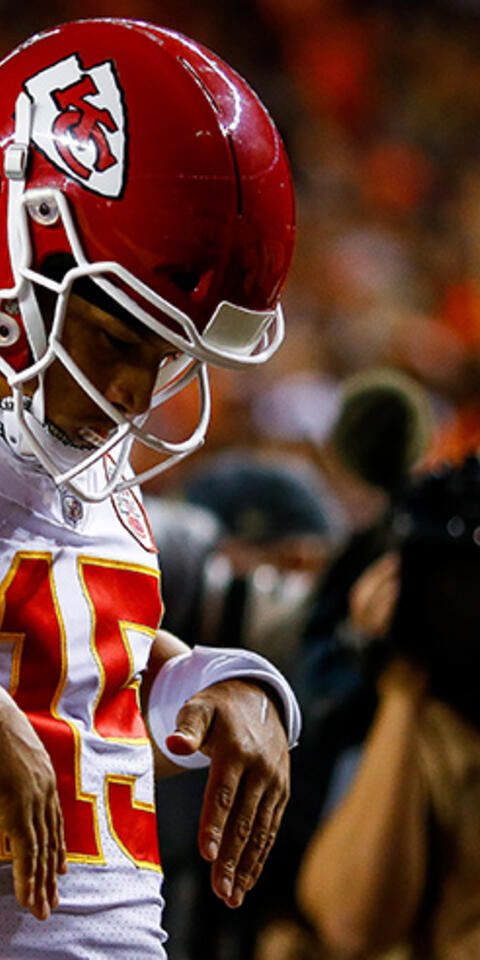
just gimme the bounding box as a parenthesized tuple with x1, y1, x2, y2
(298, 459, 480, 960)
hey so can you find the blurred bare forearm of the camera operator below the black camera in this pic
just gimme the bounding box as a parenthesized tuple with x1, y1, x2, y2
(298, 672, 425, 957)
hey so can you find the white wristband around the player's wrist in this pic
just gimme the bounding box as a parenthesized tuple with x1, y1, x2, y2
(148, 647, 301, 769)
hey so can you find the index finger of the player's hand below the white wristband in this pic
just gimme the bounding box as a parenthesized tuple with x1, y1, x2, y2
(198, 762, 242, 872)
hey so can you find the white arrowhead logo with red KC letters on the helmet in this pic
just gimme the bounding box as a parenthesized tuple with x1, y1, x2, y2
(25, 54, 127, 197)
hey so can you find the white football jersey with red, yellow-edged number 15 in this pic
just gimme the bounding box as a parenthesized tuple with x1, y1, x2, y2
(0, 439, 166, 960)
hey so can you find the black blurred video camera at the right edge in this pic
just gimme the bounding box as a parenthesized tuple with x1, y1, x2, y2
(388, 457, 480, 725)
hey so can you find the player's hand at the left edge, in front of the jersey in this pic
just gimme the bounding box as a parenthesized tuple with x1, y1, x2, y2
(0, 689, 67, 920)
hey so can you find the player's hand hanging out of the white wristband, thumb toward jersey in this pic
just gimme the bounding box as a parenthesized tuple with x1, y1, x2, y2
(167, 680, 290, 907)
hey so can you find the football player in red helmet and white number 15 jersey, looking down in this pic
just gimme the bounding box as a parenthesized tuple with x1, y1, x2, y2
(0, 19, 299, 960)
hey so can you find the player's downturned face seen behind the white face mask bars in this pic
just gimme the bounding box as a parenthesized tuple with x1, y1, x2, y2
(45, 296, 175, 441)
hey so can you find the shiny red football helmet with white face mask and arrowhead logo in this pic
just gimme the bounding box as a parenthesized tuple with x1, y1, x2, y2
(0, 19, 294, 500)
